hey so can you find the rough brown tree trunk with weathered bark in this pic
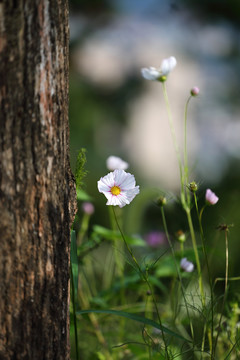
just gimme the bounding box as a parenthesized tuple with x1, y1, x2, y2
(0, 0, 75, 360)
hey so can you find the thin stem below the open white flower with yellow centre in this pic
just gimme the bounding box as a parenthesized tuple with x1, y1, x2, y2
(112, 206, 169, 359)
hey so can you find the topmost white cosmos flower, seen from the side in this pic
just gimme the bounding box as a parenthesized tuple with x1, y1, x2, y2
(141, 56, 177, 81)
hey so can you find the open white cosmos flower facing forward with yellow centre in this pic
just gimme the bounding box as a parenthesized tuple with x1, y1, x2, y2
(98, 169, 139, 207)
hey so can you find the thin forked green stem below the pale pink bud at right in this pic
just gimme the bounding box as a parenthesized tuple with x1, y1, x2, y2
(193, 197, 214, 359)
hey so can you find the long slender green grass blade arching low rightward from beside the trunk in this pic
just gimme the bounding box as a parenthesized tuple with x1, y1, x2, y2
(76, 309, 190, 342)
